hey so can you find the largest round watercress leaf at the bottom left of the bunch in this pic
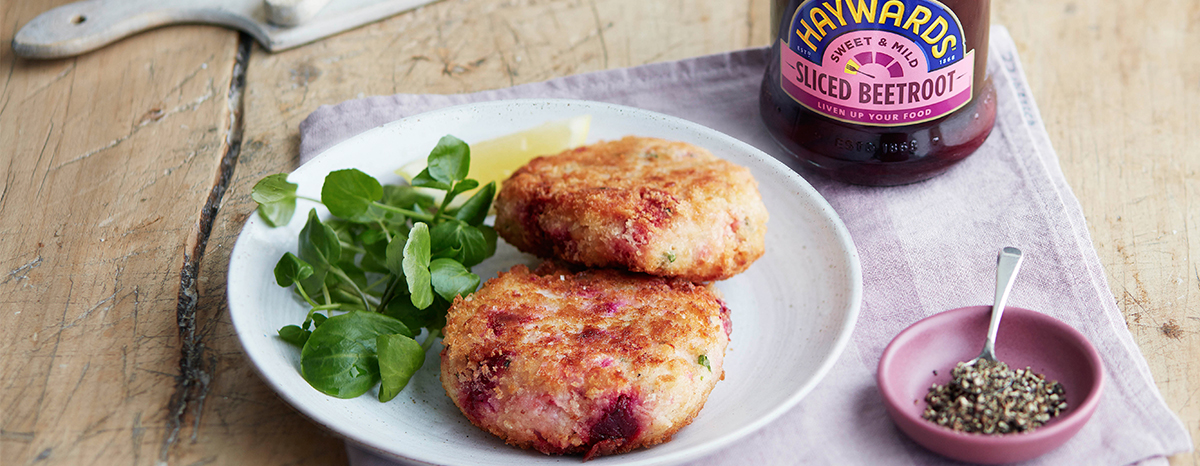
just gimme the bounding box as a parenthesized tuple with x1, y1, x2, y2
(300, 311, 413, 398)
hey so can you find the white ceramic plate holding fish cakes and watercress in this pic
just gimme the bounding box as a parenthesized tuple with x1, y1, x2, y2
(228, 100, 862, 466)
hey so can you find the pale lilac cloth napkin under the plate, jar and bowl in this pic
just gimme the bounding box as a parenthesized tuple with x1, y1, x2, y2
(300, 26, 1192, 466)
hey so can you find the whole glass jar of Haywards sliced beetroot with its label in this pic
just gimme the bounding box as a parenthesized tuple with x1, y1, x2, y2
(760, 0, 996, 186)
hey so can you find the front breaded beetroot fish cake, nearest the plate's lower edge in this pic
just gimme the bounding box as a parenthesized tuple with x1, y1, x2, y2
(442, 265, 731, 459)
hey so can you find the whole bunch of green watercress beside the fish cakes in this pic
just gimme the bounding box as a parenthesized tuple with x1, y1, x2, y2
(251, 136, 496, 401)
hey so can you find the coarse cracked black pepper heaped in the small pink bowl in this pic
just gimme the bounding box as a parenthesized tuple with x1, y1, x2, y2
(922, 359, 1067, 435)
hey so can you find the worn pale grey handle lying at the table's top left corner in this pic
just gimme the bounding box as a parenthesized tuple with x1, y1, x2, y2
(12, 0, 266, 59)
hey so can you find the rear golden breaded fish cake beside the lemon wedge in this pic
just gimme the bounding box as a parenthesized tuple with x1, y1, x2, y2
(496, 137, 767, 281)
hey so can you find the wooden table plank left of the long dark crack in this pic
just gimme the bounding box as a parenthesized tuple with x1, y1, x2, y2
(0, 2, 236, 465)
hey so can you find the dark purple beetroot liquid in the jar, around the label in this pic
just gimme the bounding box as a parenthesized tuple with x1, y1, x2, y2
(760, 0, 996, 186)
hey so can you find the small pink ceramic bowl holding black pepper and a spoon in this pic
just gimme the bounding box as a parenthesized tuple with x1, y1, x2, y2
(875, 306, 1104, 464)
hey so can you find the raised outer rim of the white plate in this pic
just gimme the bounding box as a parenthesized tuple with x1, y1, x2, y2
(226, 98, 863, 466)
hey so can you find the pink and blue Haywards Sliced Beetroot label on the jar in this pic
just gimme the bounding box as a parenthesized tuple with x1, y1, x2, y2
(779, 0, 974, 126)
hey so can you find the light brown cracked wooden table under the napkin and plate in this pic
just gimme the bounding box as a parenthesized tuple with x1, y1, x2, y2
(0, 0, 1200, 465)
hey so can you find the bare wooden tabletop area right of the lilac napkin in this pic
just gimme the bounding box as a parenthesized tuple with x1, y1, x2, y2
(992, 0, 1200, 465)
